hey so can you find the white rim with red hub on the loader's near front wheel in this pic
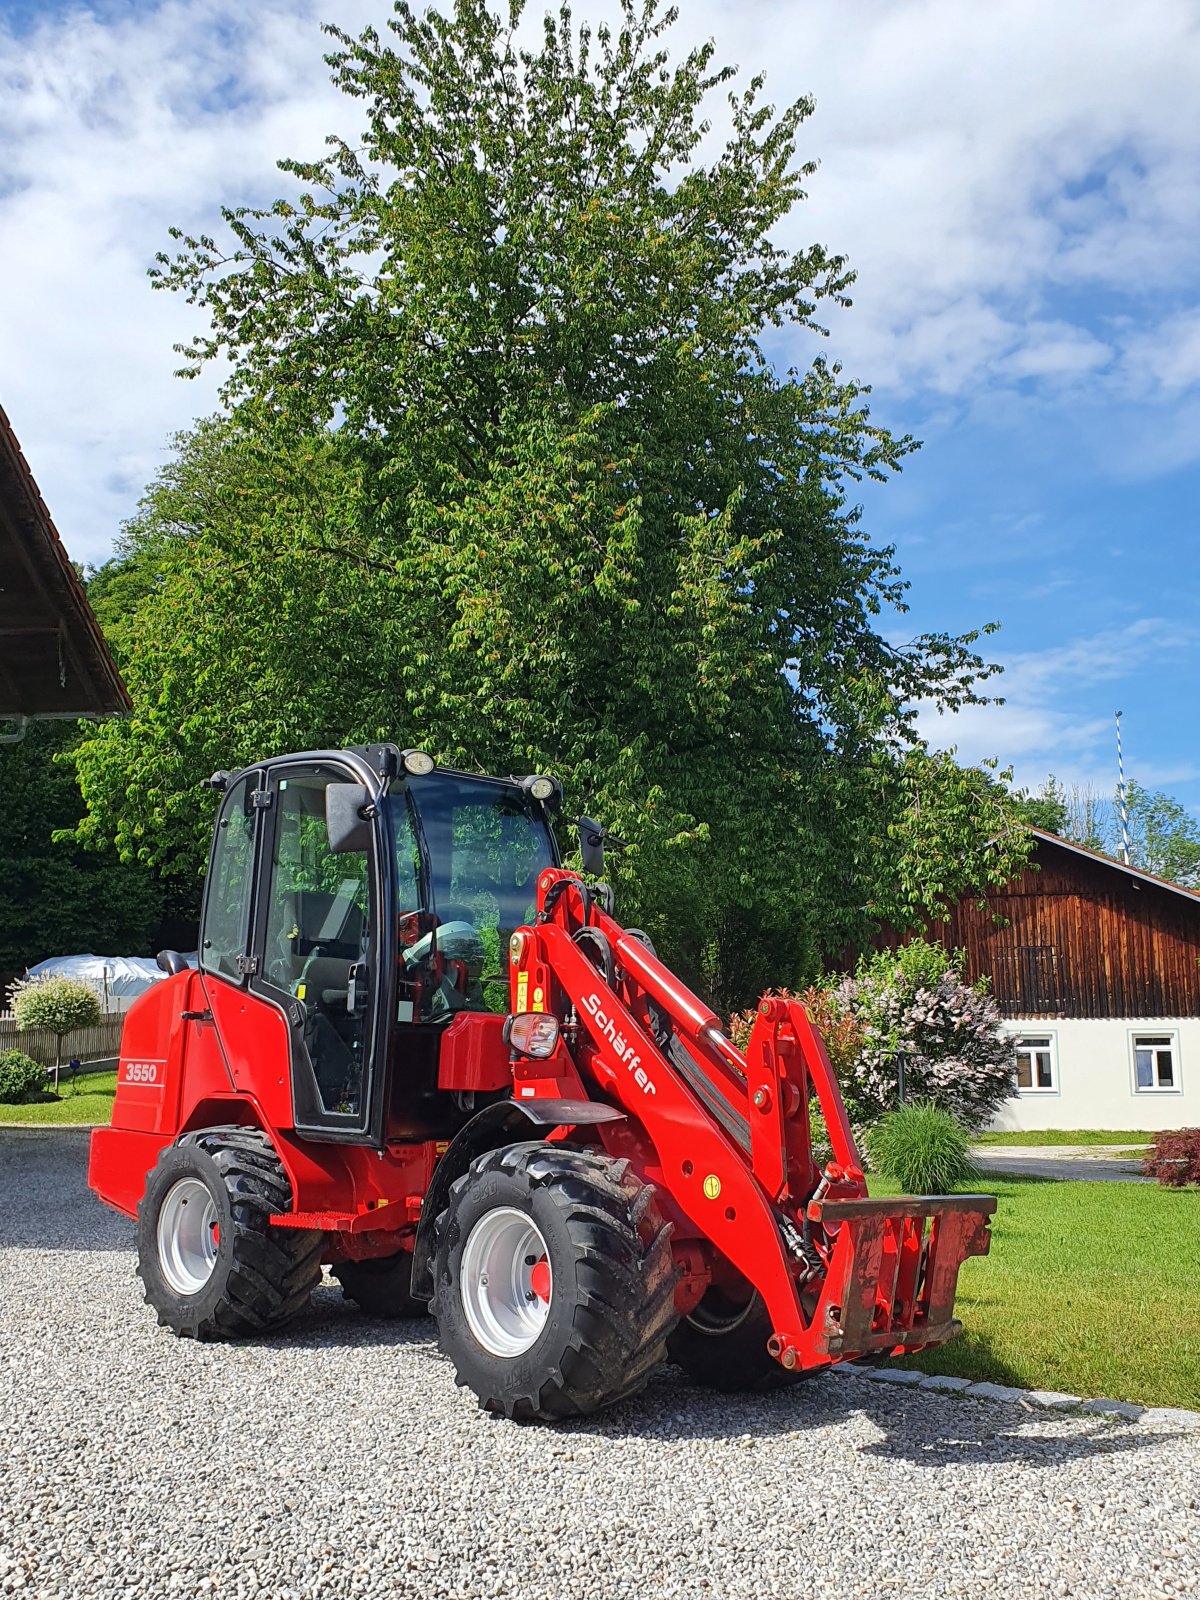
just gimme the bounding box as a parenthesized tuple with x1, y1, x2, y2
(459, 1206, 554, 1360)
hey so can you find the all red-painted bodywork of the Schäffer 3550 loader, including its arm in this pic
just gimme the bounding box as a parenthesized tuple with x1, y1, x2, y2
(90, 869, 995, 1368)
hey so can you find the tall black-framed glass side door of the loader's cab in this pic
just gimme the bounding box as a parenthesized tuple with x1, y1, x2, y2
(250, 760, 386, 1144)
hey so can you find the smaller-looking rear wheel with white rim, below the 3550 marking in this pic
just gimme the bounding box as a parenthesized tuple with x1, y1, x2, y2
(138, 1128, 325, 1339)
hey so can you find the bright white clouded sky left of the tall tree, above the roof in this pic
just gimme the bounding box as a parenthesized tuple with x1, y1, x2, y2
(0, 0, 378, 560)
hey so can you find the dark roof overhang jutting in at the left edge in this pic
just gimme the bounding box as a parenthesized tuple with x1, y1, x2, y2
(0, 410, 131, 720)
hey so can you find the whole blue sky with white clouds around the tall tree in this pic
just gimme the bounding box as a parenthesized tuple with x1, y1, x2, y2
(0, 0, 1200, 814)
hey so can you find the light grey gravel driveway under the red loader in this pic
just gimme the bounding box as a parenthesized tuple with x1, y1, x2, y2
(0, 1131, 1200, 1600)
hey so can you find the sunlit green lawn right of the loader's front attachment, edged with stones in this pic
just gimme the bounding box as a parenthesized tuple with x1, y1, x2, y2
(870, 1176, 1200, 1410)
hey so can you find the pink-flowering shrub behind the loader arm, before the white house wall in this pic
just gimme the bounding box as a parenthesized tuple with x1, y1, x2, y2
(730, 939, 1016, 1130)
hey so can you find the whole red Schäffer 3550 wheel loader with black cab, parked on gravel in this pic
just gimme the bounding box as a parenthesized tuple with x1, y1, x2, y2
(90, 744, 995, 1421)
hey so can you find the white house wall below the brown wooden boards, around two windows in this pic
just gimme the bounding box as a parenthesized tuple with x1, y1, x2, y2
(992, 1018, 1200, 1133)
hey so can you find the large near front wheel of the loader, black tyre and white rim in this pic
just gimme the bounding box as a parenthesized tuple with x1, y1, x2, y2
(432, 1142, 677, 1422)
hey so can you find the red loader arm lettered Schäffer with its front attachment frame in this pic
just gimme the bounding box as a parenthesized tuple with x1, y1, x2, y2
(510, 869, 995, 1368)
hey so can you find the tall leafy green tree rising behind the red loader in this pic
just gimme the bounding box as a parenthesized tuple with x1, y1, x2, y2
(78, 0, 1026, 1003)
